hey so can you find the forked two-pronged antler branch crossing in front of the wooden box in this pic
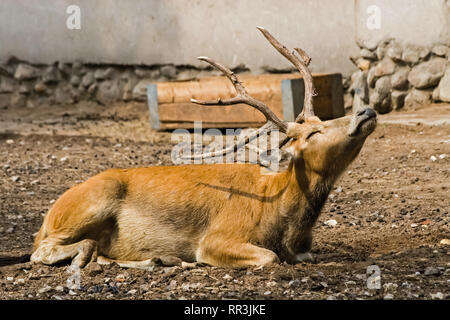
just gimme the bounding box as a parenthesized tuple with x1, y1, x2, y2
(191, 57, 287, 133)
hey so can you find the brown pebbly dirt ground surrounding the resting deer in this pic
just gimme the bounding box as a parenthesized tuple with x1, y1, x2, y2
(0, 103, 450, 300)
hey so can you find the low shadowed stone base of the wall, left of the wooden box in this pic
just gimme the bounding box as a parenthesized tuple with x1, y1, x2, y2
(0, 58, 230, 109)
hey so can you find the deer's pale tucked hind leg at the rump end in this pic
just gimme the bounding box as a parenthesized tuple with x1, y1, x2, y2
(31, 237, 97, 268)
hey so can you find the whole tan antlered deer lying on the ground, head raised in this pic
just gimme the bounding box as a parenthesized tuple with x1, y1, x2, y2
(31, 27, 377, 269)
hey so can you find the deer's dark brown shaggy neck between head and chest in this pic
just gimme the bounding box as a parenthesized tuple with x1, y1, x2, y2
(263, 161, 336, 260)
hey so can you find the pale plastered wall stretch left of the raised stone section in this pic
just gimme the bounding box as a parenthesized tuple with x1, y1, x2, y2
(0, 0, 358, 73)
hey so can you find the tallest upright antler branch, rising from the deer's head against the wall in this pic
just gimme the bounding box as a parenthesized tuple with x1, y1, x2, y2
(257, 27, 315, 122)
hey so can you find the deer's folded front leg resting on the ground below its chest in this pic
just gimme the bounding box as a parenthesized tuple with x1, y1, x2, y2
(196, 237, 279, 267)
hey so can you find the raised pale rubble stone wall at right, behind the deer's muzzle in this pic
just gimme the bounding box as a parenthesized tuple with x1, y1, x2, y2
(345, 38, 450, 113)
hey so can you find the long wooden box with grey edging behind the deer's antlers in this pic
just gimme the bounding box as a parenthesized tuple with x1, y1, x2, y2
(147, 73, 344, 130)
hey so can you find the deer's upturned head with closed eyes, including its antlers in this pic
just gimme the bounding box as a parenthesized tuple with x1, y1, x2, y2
(185, 27, 376, 177)
